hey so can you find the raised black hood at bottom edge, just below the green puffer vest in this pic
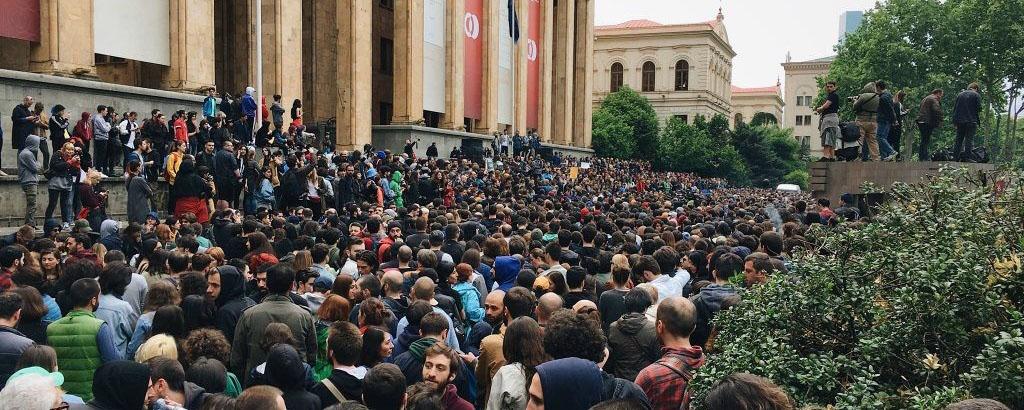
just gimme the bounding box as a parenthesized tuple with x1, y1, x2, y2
(88, 361, 150, 410)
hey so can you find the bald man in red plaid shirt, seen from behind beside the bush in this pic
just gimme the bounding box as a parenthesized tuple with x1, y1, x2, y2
(636, 296, 705, 409)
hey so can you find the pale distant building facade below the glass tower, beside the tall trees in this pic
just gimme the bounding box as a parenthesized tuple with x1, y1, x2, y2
(782, 56, 835, 157)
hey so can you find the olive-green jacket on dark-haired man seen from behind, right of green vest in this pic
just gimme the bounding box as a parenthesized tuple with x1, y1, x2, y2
(230, 294, 316, 385)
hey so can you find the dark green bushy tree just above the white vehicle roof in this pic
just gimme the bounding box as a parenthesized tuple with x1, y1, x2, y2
(730, 124, 806, 188)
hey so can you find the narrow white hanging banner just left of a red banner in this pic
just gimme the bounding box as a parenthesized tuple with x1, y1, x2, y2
(423, 0, 445, 113)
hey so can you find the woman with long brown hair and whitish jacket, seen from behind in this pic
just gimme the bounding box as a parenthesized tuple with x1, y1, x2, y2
(486, 317, 550, 410)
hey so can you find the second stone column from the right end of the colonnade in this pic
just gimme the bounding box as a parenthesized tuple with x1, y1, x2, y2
(550, 0, 575, 145)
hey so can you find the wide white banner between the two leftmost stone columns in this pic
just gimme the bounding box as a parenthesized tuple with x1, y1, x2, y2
(92, 0, 171, 66)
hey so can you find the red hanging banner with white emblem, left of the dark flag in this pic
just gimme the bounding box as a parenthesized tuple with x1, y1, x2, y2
(462, 0, 483, 120)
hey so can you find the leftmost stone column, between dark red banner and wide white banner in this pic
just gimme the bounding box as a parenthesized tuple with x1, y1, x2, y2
(29, 0, 96, 78)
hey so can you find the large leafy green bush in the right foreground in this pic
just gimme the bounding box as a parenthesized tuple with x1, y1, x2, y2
(691, 170, 1024, 409)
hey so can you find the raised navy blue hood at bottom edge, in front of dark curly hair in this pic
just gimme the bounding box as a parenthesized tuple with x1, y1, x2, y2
(537, 358, 603, 410)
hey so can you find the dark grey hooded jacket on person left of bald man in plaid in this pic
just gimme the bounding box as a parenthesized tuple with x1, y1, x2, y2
(604, 313, 660, 380)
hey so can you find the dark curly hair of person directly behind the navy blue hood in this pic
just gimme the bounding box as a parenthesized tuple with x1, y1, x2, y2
(544, 310, 607, 363)
